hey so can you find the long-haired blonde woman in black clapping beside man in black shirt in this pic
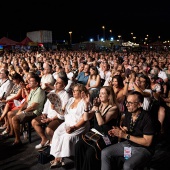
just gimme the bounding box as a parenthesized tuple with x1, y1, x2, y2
(75, 86, 120, 170)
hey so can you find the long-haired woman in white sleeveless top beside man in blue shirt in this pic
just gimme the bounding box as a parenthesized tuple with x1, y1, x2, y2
(86, 67, 101, 103)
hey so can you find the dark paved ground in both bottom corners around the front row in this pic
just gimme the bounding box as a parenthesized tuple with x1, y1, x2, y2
(0, 125, 170, 170)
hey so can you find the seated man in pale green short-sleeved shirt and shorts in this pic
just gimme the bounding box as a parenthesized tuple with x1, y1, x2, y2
(12, 74, 46, 146)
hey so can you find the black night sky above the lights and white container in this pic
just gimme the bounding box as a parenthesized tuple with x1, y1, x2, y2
(0, 0, 170, 42)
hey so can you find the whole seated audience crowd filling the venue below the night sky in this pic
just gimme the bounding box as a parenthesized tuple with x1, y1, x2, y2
(0, 50, 170, 170)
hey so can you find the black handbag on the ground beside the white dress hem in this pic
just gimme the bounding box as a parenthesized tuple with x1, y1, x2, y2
(37, 146, 54, 164)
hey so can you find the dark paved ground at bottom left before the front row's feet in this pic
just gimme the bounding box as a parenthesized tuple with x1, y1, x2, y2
(0, 131, 75, 170)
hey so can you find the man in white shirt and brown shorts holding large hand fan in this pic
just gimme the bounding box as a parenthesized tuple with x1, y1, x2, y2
(31, 74, 69, 149)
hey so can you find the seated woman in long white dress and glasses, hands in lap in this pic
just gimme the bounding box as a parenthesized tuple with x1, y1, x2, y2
(50, 84, 90, 168)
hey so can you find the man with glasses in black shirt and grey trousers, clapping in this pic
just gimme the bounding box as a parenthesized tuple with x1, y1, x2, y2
(101, 91, 155, 170)
